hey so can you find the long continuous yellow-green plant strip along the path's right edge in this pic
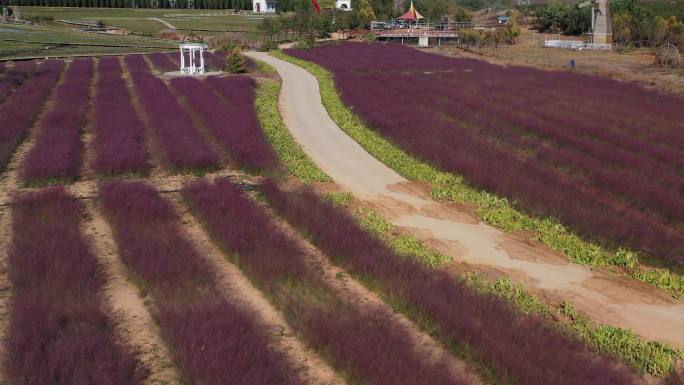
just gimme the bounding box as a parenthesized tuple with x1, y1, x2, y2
(271, 51, 684, 298)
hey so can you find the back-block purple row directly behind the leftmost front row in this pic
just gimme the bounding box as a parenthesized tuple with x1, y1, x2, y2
(21, 59, 94, 182)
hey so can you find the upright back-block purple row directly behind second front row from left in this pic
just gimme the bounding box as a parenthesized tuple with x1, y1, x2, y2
(93, 58, 149, 175)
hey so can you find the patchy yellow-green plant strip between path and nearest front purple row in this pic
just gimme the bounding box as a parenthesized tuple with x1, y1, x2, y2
(344, 200, 684, 377)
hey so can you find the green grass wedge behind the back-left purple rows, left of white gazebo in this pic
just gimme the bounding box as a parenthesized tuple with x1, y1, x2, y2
(0, 24, 177, 59)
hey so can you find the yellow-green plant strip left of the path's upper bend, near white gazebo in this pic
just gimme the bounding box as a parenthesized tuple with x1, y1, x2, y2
(256, 66, 332, 182)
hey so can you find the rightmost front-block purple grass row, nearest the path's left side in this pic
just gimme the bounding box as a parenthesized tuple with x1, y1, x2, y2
(261, 179, 638, 385)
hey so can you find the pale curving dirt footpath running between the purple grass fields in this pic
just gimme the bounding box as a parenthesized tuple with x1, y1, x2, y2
(247, 52, 684, 347)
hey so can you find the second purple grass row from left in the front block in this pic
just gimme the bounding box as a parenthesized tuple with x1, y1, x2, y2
(100, 181, 297, 385)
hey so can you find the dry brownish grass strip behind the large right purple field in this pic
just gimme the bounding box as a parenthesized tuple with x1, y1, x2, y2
(434, 28, 684, 94)
